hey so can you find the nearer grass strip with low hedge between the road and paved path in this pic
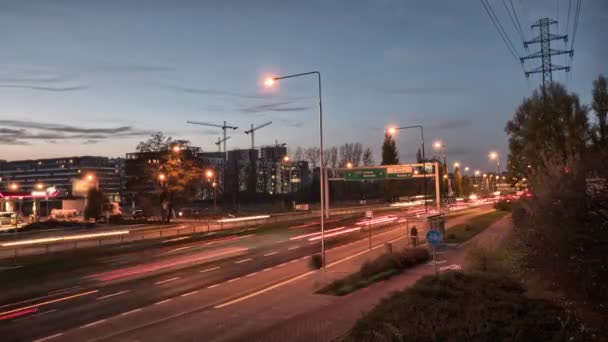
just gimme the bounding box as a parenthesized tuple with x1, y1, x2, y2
(316, 248, 430, 296)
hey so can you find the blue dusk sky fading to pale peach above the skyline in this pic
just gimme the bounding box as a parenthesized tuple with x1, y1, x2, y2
(0, 0, 608, 170)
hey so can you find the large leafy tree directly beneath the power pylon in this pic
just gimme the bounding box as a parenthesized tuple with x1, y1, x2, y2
(505, 83, 589, 178)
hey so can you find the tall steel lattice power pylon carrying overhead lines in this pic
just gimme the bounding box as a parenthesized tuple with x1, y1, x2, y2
(520, 18, 574, 97)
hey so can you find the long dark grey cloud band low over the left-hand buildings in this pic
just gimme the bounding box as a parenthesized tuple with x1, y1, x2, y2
(0, 120, 152, 145)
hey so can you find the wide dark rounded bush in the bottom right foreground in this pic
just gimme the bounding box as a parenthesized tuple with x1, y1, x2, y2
(345, 272, 580, 341)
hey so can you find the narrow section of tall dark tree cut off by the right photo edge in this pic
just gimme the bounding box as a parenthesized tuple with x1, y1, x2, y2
(591, 75, 608, 149)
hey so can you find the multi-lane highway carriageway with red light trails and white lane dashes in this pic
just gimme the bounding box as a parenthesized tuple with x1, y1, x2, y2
(0, 204, 492, 341)
